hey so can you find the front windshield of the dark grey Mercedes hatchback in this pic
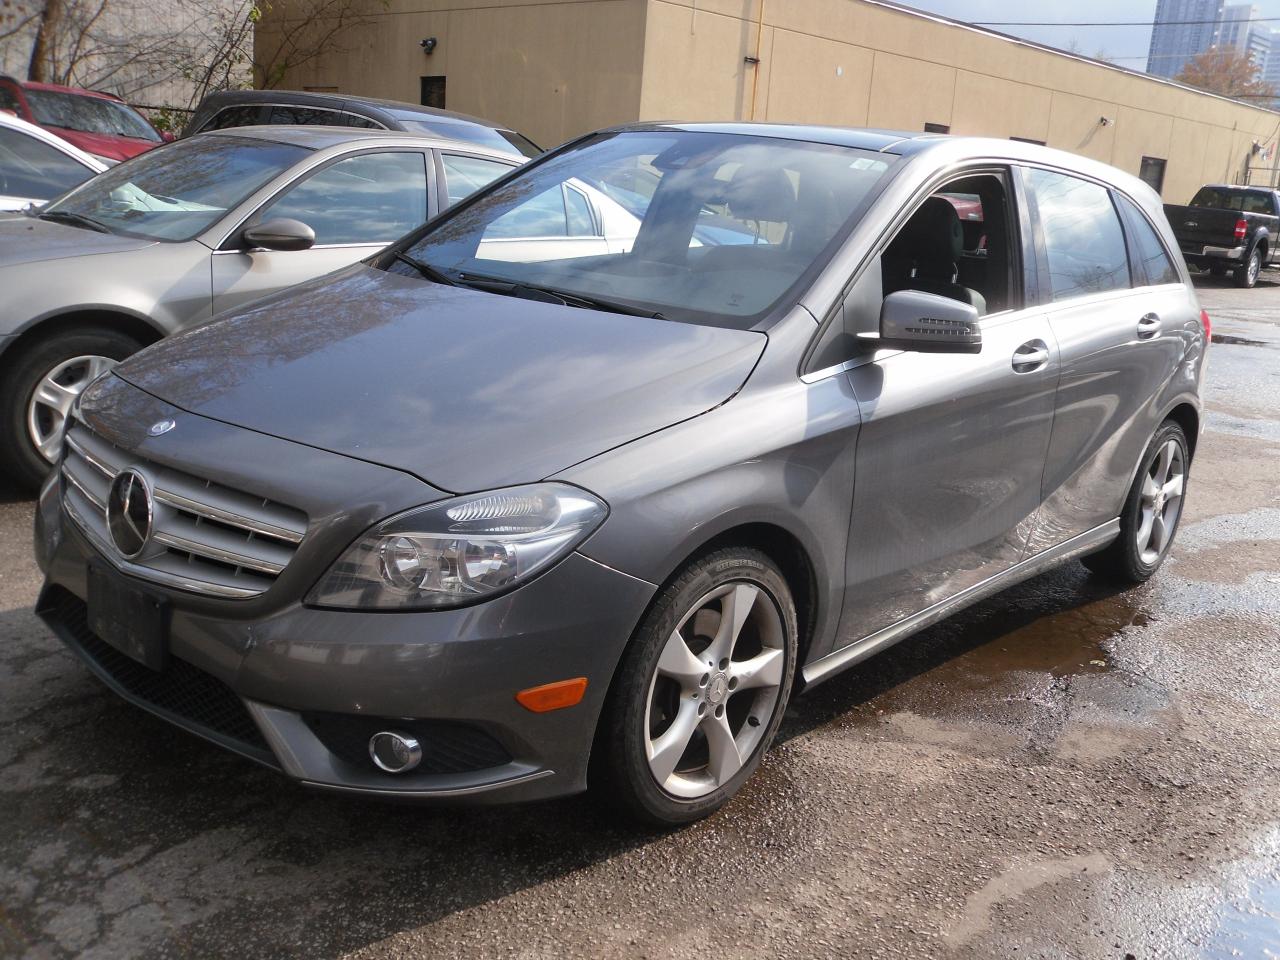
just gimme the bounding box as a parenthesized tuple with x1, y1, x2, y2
(385, 131, 896, 328)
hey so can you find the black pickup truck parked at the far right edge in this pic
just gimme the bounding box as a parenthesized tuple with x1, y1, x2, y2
(1165, 184, 1280, 287)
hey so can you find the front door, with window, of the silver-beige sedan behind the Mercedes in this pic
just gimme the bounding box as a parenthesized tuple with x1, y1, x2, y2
(212, 150, 435, 314)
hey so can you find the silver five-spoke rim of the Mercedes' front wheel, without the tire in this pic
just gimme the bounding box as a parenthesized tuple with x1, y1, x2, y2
(645, 581, 786, 799)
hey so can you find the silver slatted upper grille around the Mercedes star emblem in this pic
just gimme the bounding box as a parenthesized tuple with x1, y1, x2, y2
(63, 421, 307, 599)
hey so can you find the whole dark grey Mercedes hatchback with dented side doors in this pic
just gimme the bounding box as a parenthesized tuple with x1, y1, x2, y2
(35, 123, 1208, 823)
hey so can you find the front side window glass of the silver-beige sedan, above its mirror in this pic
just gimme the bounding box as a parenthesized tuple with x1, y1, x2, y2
(259, 152, 426, 244)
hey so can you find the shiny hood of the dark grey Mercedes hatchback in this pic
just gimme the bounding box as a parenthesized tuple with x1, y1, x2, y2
(115, 264, 765, 492)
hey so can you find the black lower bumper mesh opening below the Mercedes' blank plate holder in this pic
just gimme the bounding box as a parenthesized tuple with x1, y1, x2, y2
(40, 588, 275, 765)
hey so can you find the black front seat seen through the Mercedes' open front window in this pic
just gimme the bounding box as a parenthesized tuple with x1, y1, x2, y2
(882, 197, 987, 316)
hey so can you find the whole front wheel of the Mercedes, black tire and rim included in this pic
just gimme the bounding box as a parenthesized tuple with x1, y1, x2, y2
(591, 548, 797, 827)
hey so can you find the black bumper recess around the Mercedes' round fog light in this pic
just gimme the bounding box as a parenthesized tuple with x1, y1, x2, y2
(302, 713, 511, 773)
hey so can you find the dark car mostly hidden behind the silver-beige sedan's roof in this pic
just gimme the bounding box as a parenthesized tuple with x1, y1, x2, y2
(183, 90, 543, 157)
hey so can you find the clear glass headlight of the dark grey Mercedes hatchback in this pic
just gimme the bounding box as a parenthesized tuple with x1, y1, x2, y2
(307, 484, 608, 609)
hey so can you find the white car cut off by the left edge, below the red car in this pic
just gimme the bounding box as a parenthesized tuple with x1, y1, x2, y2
(0, 113, 106, 212)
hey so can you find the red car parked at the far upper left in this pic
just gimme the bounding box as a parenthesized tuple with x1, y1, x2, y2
(0, 77, 165, 161)
